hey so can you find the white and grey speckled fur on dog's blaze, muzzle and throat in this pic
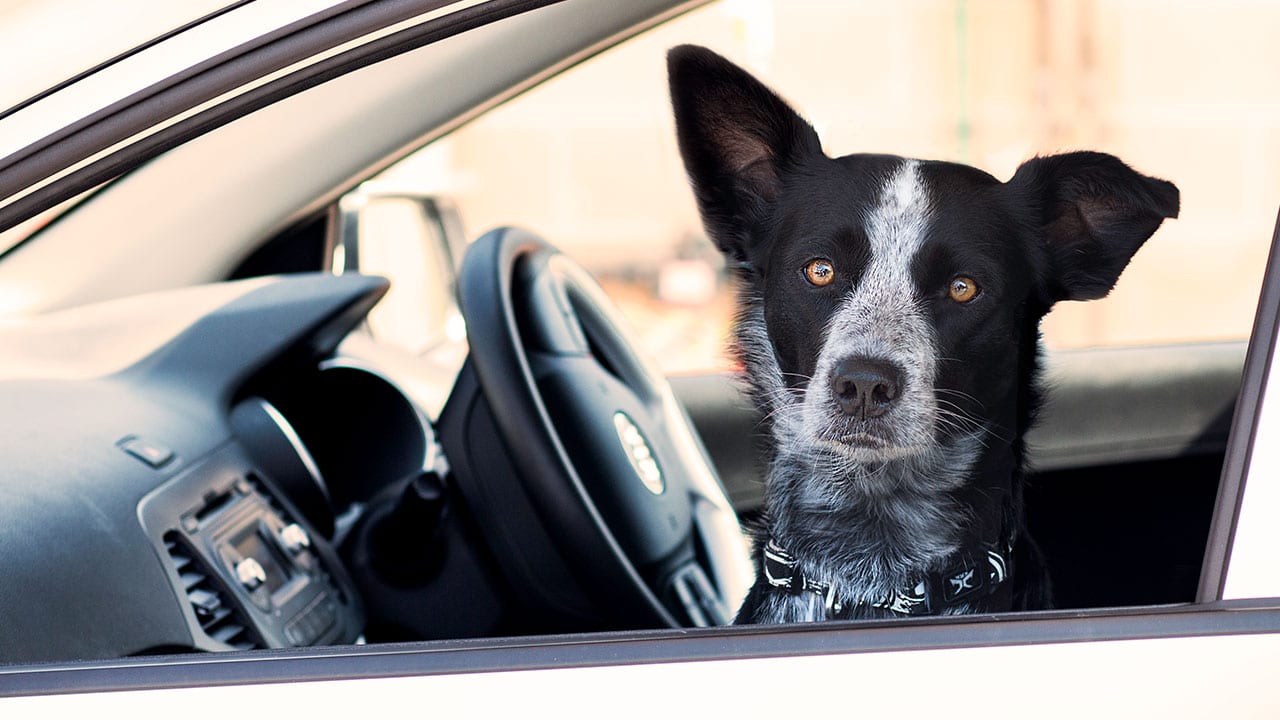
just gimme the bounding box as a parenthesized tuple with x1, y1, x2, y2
(737, 160, 983, 623)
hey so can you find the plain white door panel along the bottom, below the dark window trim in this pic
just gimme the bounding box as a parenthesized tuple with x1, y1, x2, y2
(0, 611, 1280, 719)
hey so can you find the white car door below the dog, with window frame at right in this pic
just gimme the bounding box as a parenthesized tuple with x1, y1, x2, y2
(0, 0, 1280, 717)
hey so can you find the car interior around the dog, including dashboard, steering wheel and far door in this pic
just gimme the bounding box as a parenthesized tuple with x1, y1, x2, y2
(0, 0, 1267, 664)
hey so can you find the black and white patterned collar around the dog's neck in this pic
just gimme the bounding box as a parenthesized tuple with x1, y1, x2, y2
(762, 536, 1014, 619)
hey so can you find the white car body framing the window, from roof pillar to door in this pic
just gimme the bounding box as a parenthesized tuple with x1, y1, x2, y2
(0, 0, 1280, 717)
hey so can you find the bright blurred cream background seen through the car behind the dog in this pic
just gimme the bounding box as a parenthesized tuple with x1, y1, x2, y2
(379, 0, 1280, 372)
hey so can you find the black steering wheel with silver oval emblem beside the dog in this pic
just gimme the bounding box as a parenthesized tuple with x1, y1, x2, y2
(451, 228, 753, 626)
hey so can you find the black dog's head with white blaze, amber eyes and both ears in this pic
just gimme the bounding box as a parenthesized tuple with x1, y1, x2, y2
(668, 46, 1178, 464)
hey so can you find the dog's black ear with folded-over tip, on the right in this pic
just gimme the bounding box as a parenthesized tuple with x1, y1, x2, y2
(1009, 152, 1178, 302)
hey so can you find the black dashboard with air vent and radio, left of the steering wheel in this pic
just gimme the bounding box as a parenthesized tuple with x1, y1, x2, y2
(0, 274, 386, 662)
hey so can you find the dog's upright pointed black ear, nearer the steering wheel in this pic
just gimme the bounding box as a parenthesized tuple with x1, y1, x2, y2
(667, 45, 822, 264)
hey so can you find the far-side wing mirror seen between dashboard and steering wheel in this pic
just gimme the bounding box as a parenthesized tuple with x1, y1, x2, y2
(328, 183, 466, 355)
